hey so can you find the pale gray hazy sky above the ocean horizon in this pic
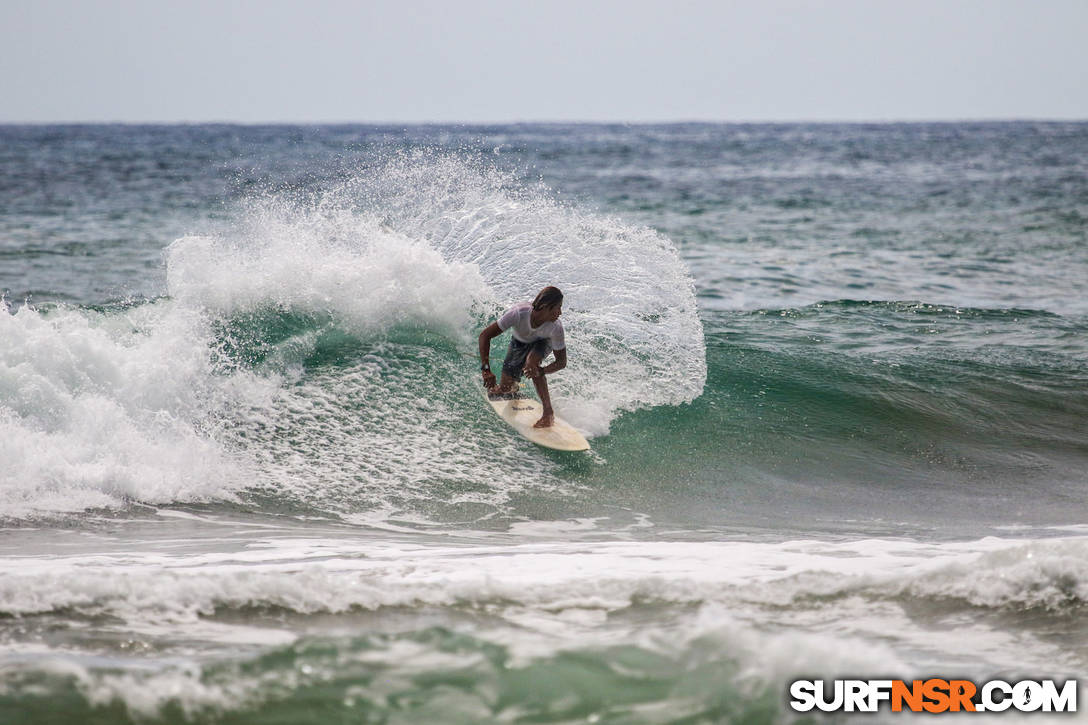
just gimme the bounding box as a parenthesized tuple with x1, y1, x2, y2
(0, 0, 1088, 122)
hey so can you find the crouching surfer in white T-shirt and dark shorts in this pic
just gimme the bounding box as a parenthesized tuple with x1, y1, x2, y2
(480, 287, 567, 428)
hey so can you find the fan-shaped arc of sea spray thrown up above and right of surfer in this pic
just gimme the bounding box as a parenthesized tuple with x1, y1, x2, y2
(333, 150, 706, 428)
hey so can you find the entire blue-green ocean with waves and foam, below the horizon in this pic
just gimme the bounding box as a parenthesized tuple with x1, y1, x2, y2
(0, 123, 1088, 724)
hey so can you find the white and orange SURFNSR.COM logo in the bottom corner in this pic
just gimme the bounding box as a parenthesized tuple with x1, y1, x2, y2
(790, 677, 1077, 713)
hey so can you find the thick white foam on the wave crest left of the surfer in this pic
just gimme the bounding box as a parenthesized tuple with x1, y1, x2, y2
(165, 199, 487, 337)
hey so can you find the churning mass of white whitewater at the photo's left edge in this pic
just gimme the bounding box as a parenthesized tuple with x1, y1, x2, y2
(0, 302, 269, 516)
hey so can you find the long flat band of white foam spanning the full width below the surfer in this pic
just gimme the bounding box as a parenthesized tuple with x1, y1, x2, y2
(0, 538, 1088, 622)
